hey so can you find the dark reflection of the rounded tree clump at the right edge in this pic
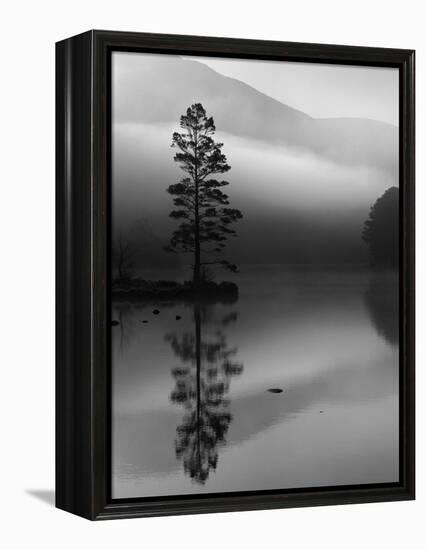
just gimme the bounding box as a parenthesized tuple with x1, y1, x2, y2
(364, 273, 399, 345)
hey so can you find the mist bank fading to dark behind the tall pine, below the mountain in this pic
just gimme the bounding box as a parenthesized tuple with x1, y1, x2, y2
(112, 123, 397, 268)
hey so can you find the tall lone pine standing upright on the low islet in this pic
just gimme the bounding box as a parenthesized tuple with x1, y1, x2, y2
(167, 103, 242, 285)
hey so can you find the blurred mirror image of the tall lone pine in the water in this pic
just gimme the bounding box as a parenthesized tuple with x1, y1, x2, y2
(166, 304, 243, 484)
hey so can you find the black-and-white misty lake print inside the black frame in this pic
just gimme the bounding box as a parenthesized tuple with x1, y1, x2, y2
(110, 51, 399, 499)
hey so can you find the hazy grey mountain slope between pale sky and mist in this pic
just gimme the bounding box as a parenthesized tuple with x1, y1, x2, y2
(113, 54, 398, 171)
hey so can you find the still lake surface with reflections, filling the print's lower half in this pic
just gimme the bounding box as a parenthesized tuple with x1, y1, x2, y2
(112, 265, 399, 498)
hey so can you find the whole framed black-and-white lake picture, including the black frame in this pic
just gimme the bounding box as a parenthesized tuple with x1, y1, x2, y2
(56, 31, 414, 519)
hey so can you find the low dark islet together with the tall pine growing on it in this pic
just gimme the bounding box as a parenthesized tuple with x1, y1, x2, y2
(112, 103, 242, 302)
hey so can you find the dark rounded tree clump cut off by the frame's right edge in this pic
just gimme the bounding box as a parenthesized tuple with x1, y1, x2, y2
(362, 187, 399, 267)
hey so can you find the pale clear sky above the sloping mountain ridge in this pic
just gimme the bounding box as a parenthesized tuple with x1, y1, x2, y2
(187, 57, 399, 126)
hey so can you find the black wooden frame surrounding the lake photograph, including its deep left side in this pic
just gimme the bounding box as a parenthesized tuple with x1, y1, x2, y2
(56, 30, 415, 520)
